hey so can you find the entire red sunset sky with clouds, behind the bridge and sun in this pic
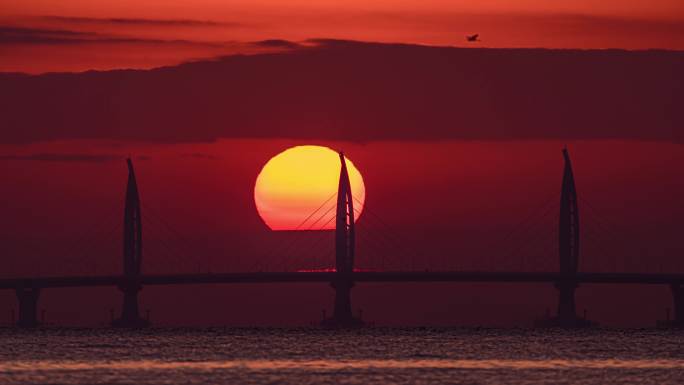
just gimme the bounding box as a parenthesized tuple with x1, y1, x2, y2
(0, 0, 684, 326)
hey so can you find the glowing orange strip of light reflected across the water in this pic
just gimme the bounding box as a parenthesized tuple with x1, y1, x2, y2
(0, 359, 684, 373)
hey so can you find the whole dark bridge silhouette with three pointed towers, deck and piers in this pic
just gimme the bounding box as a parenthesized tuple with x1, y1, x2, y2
(0, 149, 684, 328)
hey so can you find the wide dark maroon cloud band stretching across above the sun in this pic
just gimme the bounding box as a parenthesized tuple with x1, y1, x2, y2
(0, 40, 684, 143)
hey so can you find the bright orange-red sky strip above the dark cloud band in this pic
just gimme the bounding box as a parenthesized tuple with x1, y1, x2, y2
(0, 0, 684, 73)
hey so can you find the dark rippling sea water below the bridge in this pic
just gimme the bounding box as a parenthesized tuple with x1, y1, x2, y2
(0, 328, 684, 385)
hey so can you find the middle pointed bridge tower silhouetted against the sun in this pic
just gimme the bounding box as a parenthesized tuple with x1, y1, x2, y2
(322, 152, 363, 328)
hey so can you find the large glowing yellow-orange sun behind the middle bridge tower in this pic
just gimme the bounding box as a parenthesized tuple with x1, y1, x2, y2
(254, 146, 366, 230)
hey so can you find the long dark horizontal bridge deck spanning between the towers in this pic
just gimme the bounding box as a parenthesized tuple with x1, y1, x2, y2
(0, 271, 684, 289)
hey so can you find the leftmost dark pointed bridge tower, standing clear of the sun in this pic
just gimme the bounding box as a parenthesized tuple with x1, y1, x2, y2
(112, 159, 148, 327)
